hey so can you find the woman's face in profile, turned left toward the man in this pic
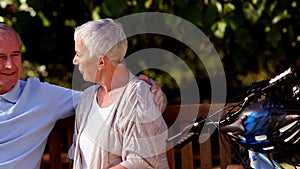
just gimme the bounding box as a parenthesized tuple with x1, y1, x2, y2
(73, 42, 98, 83)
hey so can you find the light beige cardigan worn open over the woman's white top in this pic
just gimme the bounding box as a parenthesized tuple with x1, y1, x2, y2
(69, 74, 169, 169)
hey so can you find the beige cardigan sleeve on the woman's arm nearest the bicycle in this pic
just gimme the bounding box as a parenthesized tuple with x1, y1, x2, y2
(119, 82, 167, 169)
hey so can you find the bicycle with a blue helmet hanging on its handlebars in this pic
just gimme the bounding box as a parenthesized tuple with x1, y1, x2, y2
(166, 68, 300, 169)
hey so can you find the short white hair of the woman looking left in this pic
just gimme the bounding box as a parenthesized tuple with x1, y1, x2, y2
(74, 18, 128, 63)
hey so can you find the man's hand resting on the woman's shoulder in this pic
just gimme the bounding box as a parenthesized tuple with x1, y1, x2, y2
(138, 74, 165, 112)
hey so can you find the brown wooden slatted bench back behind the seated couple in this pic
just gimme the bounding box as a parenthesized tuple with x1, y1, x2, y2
(41, 104, 242, 169)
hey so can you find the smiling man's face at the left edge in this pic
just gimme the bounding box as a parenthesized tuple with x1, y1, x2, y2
(0, 32, 22, 94)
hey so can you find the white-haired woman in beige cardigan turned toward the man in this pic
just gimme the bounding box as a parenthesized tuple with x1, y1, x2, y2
(69, 19, 168, 169)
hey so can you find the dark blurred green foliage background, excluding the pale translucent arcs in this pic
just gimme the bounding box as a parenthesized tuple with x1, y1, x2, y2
(0, 0, 300, 105)
